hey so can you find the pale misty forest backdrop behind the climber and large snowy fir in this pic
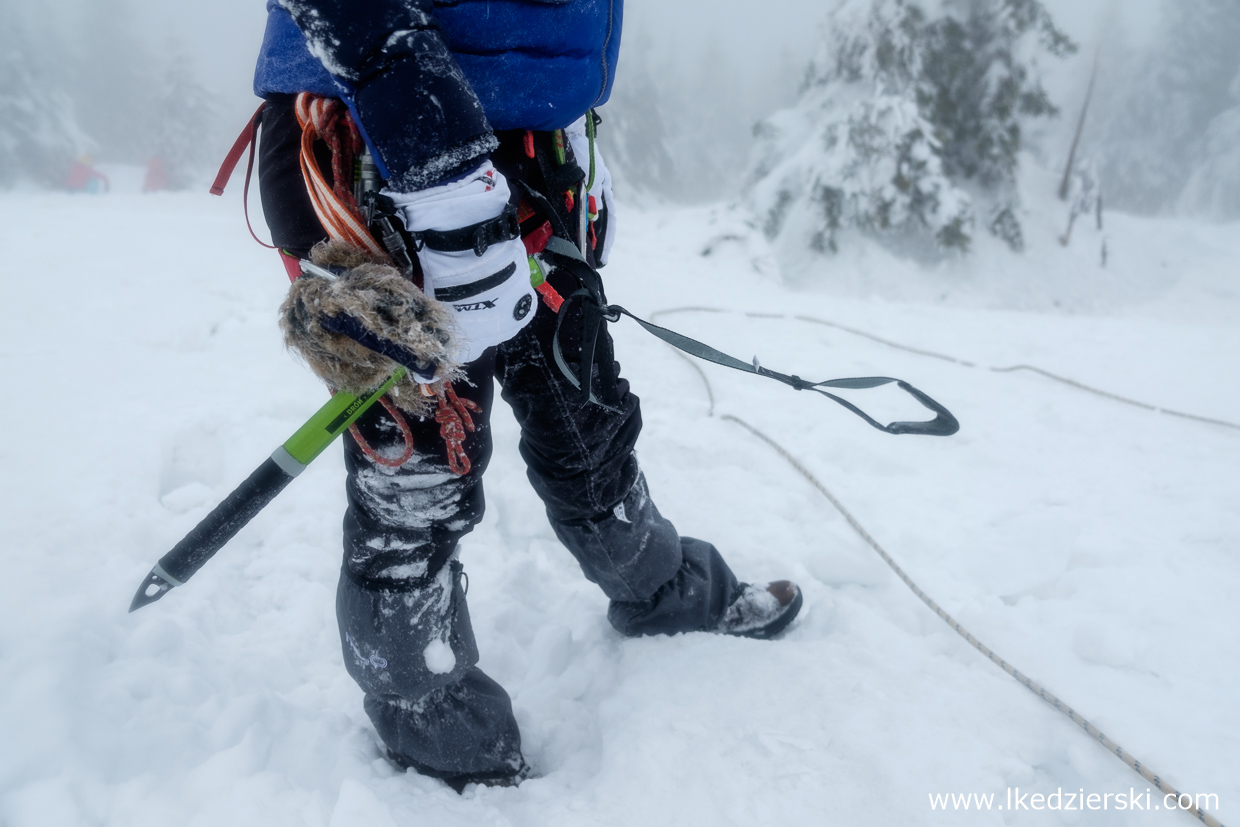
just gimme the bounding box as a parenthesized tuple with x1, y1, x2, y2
(0, 0, 1240, 218)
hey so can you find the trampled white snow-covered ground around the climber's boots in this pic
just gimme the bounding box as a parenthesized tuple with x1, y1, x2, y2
(0, 169, 1240, 827)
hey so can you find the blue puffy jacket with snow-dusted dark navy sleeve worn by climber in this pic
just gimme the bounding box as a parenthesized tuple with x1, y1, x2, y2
(254, 0, 622, 191)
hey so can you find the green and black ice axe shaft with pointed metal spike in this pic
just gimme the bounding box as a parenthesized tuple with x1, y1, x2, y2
(129, 367, 405, 611)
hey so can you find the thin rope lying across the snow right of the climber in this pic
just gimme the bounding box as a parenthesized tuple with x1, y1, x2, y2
(651, 307, 1225, 827)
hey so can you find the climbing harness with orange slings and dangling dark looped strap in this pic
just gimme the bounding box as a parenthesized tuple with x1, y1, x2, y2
(212, 100, 960, 474)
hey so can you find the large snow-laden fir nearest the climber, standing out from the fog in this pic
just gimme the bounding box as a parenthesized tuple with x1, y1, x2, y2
(750, 0, 1075, 253)
